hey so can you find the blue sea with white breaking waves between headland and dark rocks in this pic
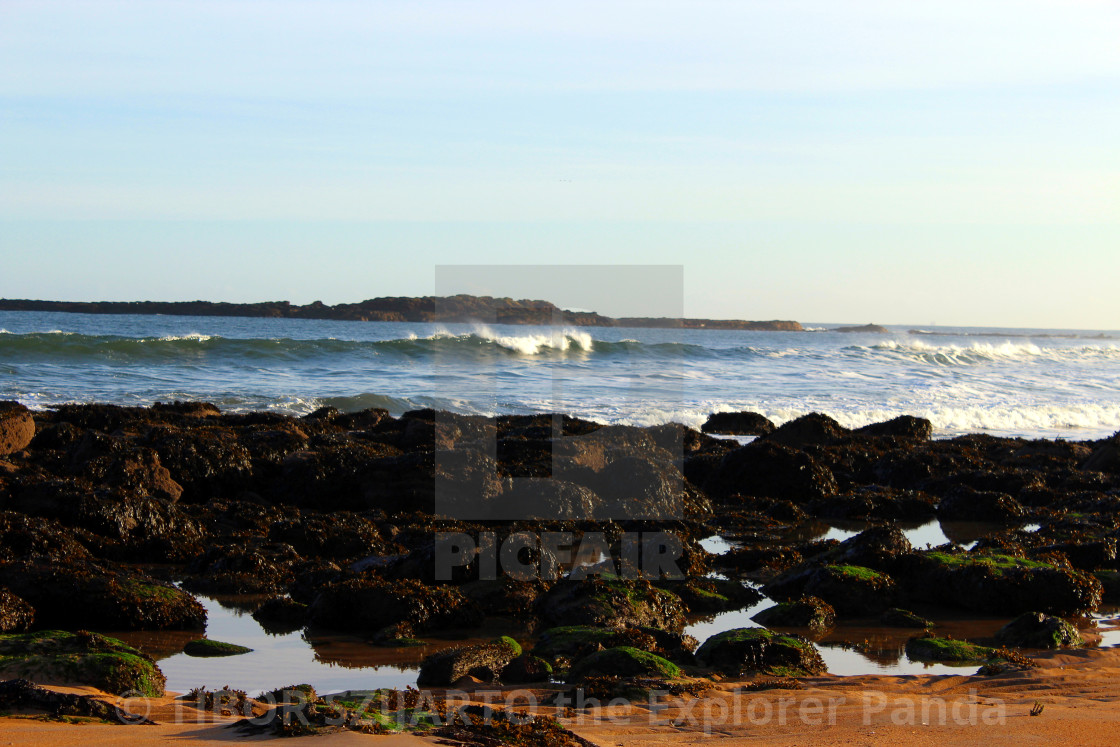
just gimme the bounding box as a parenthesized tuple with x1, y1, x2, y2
(0, 312, 1120, 439)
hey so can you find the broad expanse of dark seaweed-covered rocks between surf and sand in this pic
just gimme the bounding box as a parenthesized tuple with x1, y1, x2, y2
(0, 402, 1120, 739)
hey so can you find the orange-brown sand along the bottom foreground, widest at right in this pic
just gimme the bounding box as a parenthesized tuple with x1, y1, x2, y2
(0, 648, 1120, 747)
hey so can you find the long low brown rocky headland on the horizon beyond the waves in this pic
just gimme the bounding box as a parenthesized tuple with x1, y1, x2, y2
(0, 296, 802, 332)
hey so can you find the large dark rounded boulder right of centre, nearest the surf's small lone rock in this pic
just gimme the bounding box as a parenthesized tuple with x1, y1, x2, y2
(703, 441, 838, 503)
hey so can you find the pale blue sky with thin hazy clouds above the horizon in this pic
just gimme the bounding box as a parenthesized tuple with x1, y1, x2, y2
(0, 0, 1120, 329)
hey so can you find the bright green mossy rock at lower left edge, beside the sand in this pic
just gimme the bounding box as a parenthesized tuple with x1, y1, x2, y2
(0, 631, 165, 698)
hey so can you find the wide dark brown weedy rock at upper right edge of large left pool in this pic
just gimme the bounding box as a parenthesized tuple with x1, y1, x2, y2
(308, 578, 483, 632)
